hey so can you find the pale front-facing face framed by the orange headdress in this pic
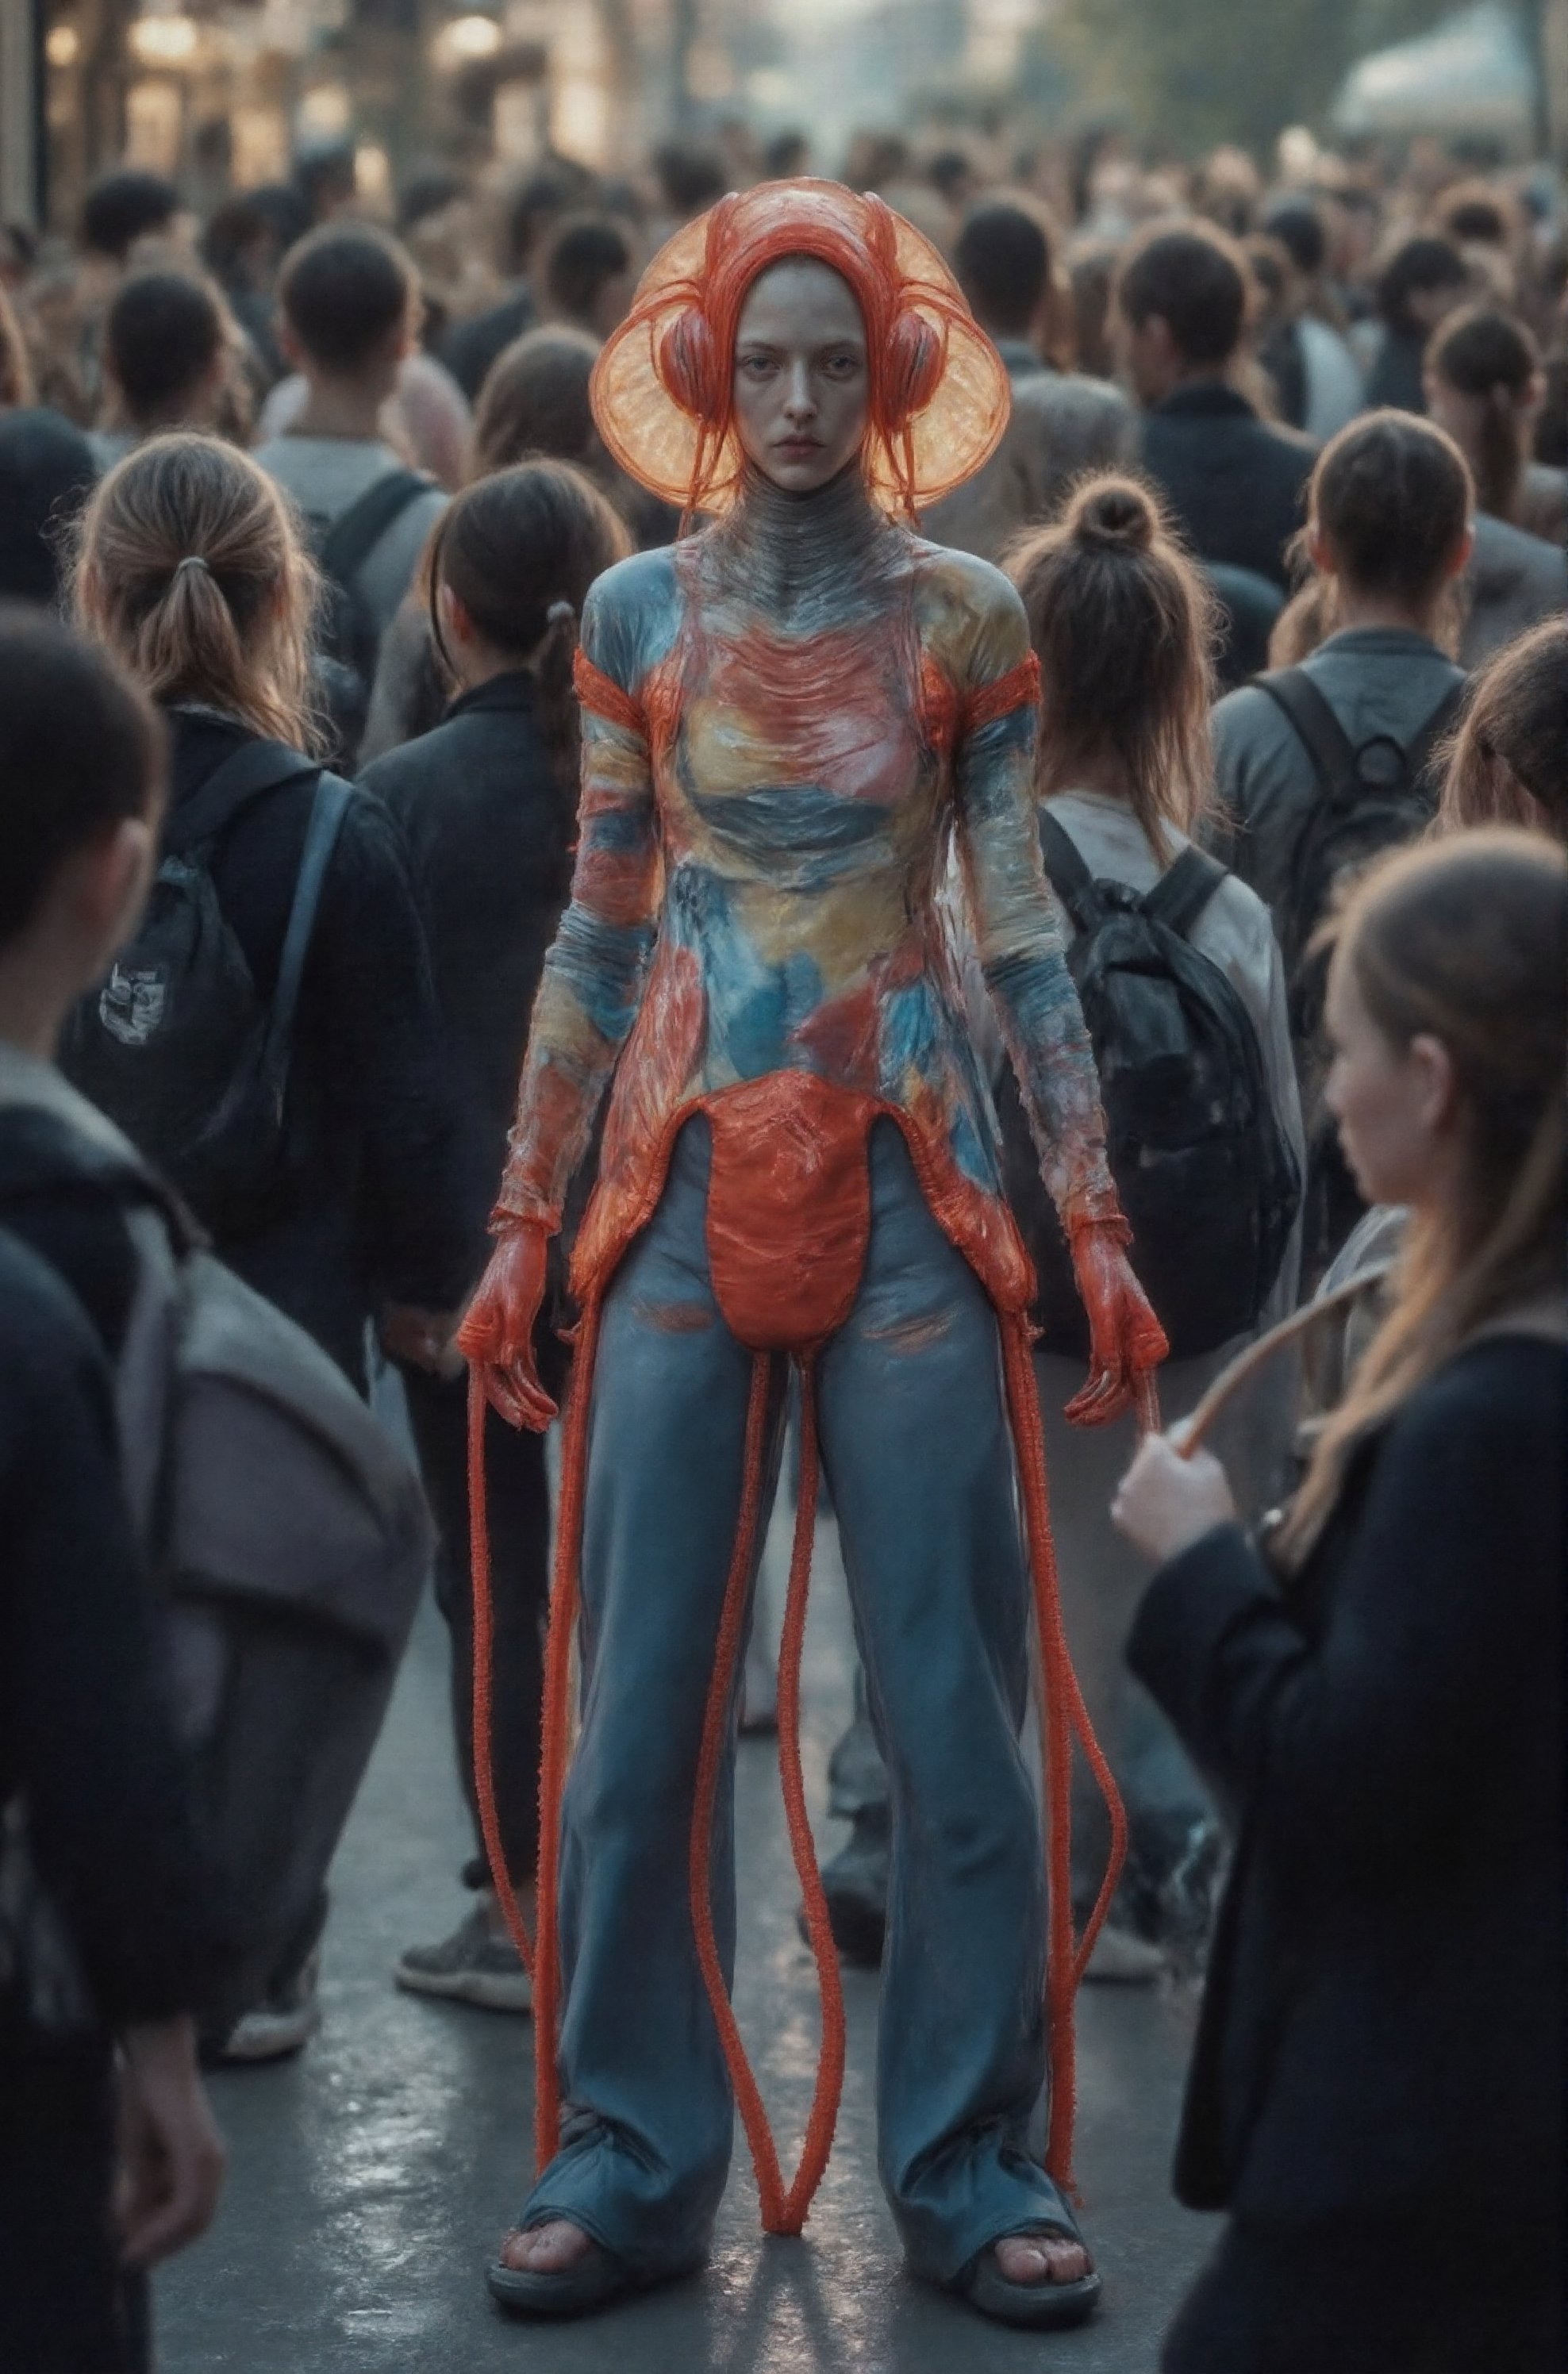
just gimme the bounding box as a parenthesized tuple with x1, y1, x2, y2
(734, 256, 870, 494)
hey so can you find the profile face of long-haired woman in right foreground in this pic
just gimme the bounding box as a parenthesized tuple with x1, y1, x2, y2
(1324, 957, 1458, 1208)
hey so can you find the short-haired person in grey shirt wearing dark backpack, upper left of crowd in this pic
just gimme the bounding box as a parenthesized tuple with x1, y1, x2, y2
(256, 223, 447, 764)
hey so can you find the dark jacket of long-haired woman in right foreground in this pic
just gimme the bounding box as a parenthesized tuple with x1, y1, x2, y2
(1128, 1335, 1568, 2248)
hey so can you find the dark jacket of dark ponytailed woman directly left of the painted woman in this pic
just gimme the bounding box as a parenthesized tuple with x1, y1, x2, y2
(361, 672, 573, 1223)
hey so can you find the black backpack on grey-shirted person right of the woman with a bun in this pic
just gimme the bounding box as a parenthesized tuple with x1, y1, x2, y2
(1255, 667, 1463, 1044)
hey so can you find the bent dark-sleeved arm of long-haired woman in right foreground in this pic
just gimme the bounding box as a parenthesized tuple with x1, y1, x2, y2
(1124, 1346, 1563, 1873)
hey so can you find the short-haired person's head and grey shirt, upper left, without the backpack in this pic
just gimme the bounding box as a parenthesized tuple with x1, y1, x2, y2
(256, 223, 447, 636)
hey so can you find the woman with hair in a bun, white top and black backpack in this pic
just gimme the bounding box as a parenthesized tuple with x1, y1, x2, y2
(997, 477, 1305, 1980)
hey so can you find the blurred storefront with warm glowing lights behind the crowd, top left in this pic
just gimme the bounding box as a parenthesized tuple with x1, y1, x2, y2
(0, 0, 715, 228)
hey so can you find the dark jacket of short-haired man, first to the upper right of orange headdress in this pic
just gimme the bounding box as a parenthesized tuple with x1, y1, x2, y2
(1140, 380, 1316, 586)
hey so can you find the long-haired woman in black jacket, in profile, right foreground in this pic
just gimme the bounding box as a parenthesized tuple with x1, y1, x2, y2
(1116, 828, 1568, 2374)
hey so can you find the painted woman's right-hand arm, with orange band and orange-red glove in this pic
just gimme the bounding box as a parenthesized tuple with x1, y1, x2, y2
(953, 563, 1166, 1422)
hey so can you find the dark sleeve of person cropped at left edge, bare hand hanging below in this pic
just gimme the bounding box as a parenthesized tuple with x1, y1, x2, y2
(0, 1234, 223, 2042)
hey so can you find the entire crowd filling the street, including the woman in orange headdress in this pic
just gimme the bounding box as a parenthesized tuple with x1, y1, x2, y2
(0, 111, 1568, 2374)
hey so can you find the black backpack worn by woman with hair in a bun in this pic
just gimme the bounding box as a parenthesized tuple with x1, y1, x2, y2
(997, 812, 1302, 1360)
